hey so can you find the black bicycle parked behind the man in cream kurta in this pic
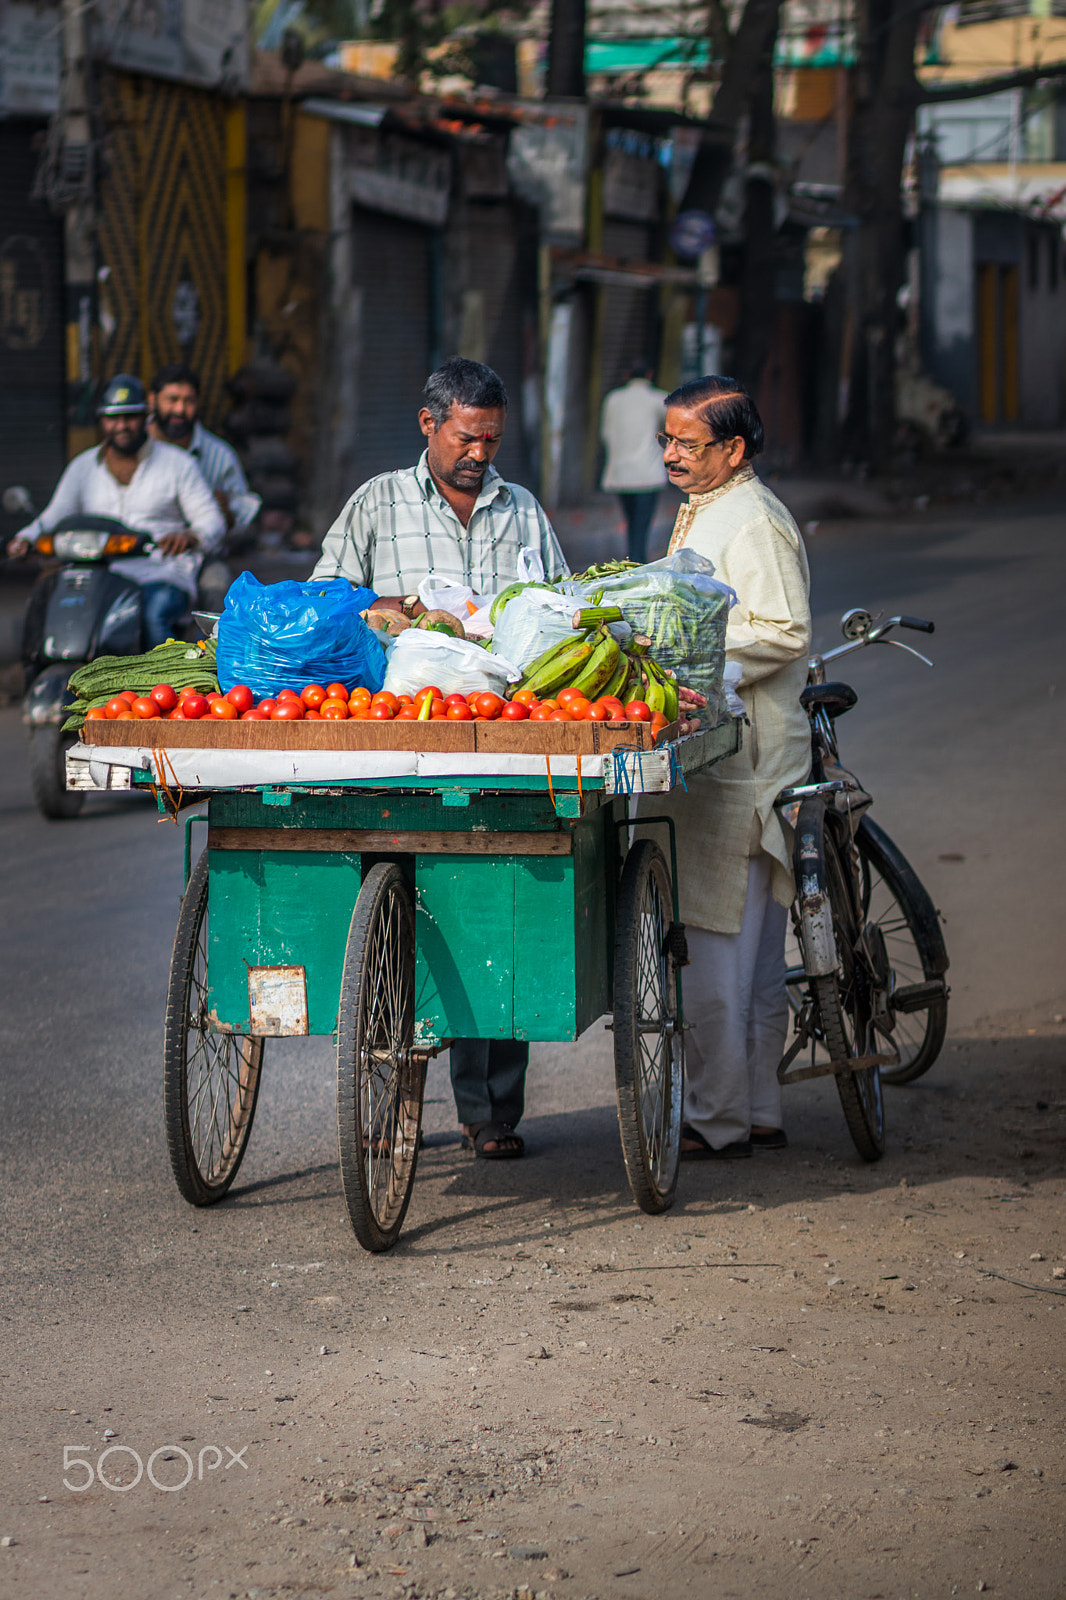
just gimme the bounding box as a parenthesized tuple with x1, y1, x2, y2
(776, 610, 949, 1162)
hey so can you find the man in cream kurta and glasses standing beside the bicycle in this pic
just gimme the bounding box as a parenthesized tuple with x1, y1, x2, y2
(640, 378, 810, 1158)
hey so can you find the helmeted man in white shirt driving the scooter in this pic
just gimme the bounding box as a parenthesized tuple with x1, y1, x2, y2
(8, 373, 226, 648)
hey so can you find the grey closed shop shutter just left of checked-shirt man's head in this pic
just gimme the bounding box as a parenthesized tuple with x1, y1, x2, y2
(350, 205, 431, 493)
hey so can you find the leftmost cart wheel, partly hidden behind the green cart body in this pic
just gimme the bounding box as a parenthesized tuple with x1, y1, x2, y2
(163, 850, 262, 1205)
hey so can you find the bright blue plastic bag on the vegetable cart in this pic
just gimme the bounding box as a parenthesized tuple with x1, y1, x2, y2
(216, 573, 386, 699)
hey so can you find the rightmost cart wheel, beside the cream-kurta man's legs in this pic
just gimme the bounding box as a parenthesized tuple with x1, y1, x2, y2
(615, 838, 685, 1213)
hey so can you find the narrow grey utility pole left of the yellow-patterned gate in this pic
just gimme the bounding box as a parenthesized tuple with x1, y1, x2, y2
(60, 0, 96, 456)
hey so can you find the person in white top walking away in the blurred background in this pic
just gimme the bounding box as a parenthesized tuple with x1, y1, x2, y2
(600, 363, 667, 565)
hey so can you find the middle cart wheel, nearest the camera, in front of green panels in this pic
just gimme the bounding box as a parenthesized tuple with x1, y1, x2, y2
(336, 861, 426, 1250)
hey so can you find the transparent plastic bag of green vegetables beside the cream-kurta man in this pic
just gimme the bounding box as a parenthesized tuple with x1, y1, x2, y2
(589, 549, 736, 720)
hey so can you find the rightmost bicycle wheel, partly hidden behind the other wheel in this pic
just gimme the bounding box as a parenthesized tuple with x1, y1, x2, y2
(855, 816, 948, 1083)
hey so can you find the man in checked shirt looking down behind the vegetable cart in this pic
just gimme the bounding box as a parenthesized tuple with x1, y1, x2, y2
(312, 357, 568, 1160)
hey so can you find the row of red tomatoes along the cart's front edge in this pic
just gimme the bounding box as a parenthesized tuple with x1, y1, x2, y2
(86, 683, 666, 733)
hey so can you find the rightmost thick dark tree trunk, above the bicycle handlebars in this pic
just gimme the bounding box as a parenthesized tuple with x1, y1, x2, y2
(845, 0, 922, 472)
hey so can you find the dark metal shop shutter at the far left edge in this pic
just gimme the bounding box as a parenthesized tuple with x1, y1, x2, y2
(0, 122, 66, 539)
